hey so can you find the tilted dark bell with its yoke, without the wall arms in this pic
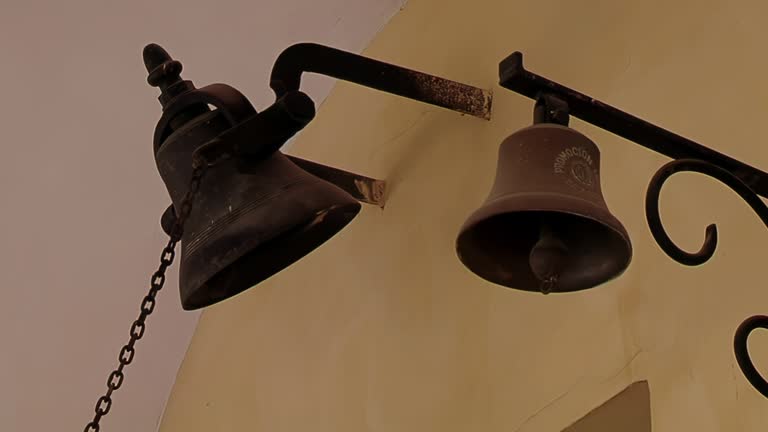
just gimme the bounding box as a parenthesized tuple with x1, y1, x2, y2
(148, 45, 360, 309)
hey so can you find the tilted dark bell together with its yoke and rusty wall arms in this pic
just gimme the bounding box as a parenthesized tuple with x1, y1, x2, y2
(144, 40, 491, 309)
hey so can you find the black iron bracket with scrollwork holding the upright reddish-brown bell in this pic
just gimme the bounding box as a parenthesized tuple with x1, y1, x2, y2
(499, 52, 768, 397)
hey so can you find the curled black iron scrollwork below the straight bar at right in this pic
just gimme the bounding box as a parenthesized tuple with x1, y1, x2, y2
(645, 159, 768, 398)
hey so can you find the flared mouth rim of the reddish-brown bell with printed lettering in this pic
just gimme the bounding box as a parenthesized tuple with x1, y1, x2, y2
(455, 192, 633, 294)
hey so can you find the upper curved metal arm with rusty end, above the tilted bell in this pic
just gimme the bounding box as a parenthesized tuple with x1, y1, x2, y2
(270, 43, 492, 120)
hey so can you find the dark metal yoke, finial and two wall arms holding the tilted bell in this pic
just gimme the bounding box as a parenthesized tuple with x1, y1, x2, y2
(152, 43, 492, 232)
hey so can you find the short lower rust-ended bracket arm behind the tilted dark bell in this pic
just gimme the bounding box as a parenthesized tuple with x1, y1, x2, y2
(288, 155, 387, 208)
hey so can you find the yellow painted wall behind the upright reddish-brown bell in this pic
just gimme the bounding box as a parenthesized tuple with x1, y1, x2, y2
(161, 0, 768, 432)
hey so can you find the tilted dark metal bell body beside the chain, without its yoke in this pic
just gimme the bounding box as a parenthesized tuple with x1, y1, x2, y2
(155, 110, 360, 310)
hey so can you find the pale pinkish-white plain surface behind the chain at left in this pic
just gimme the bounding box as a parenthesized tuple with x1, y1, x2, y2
(0, 0, 404, 432)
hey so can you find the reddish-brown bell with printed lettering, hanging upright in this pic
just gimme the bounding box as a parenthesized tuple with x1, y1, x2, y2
(456, 123, 632, 293)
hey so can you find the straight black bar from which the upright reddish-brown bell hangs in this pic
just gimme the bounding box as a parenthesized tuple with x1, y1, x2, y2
(499, 52, 768, 197)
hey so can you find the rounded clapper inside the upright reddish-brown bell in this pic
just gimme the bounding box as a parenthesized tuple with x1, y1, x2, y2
(528, 224, 568, 294)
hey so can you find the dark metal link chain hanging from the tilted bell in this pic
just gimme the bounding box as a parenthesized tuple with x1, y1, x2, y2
(84, 161, 209, 432)
